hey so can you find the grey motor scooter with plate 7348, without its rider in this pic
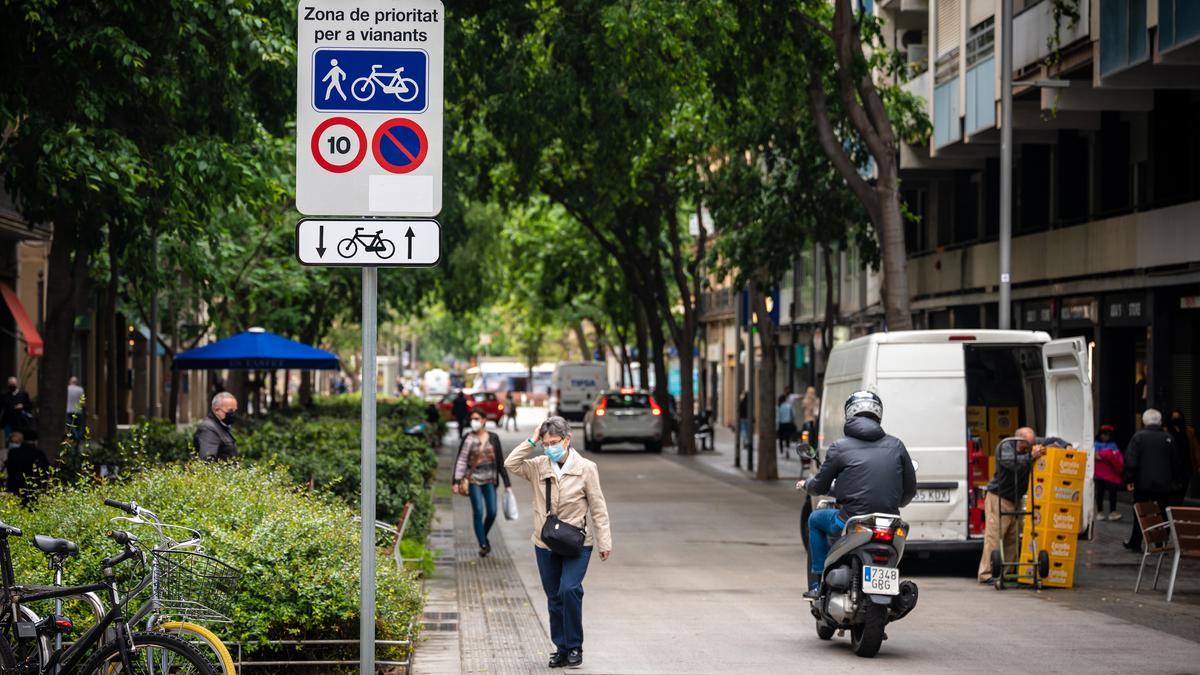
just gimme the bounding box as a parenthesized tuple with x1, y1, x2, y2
(797, 450, 917, 658)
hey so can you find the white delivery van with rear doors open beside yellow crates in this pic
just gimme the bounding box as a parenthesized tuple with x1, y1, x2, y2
(800, 330, 1094, 551)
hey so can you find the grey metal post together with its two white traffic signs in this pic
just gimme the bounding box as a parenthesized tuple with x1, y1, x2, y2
(296, 0, 445, 675)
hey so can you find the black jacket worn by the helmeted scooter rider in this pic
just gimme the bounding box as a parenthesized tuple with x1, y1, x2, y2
(805, 416, 917, 520)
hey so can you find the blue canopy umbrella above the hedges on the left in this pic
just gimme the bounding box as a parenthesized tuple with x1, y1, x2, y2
(172, 328, 340, 370)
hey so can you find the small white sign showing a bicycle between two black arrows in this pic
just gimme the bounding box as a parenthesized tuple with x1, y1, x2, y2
(296, 219, 442, 267)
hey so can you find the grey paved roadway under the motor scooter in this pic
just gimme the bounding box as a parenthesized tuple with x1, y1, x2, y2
(482, 411, 1200, 673)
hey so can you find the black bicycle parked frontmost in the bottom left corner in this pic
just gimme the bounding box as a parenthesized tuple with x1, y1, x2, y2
(0, 522, 216, 675)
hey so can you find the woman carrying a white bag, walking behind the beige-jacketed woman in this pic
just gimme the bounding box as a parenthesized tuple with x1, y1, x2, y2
(454, 410, 512, 557)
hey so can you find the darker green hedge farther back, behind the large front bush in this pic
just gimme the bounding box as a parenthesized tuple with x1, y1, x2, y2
(238, 417, 437, 542)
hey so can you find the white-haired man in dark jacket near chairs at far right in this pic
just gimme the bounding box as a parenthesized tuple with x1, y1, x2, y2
(1124, 408, 1190, 552)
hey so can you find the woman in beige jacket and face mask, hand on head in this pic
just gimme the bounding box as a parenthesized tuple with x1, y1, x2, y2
(504, 417, 612, 668)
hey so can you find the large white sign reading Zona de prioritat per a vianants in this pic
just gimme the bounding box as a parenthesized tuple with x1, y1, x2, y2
(296, 0, 445, 216)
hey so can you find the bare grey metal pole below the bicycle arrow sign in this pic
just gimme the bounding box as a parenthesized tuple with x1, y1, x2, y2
(359, 267, 376, 675)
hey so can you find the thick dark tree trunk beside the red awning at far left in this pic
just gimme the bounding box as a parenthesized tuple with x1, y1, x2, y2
(37, 214, 91, 462)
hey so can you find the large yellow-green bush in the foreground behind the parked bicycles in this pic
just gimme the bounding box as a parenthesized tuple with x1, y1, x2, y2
(0, 462, 422, 658)
